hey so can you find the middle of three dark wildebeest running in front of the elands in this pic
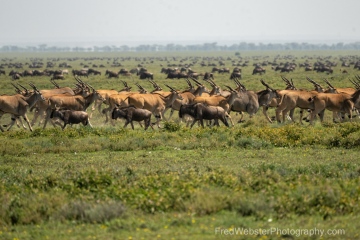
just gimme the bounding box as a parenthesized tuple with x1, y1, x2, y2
(111, 106, 154, 130)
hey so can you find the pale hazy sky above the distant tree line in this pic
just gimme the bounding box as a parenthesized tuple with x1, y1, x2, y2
(0, 0, 360, 46)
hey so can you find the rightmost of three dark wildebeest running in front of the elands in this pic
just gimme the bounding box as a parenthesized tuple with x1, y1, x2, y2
(179, 103, 229, 128)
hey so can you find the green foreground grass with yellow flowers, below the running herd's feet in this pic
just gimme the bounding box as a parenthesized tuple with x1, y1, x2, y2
(0, 124, 360, 239)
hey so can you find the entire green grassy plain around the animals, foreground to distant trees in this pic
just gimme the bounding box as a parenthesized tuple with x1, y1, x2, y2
(0, 49, 360, 239)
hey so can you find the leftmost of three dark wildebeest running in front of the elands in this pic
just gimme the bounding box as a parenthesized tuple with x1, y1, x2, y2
(50, 109, 92, 130)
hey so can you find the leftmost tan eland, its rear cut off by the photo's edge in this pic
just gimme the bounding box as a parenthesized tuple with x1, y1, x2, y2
(0, 83, 45, 131)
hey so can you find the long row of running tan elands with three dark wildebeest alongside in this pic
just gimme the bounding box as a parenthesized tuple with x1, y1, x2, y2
(0, 75, 360, 131)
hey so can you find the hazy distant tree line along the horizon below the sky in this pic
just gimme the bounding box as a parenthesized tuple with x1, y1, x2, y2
(0, 42, 360, 52)
